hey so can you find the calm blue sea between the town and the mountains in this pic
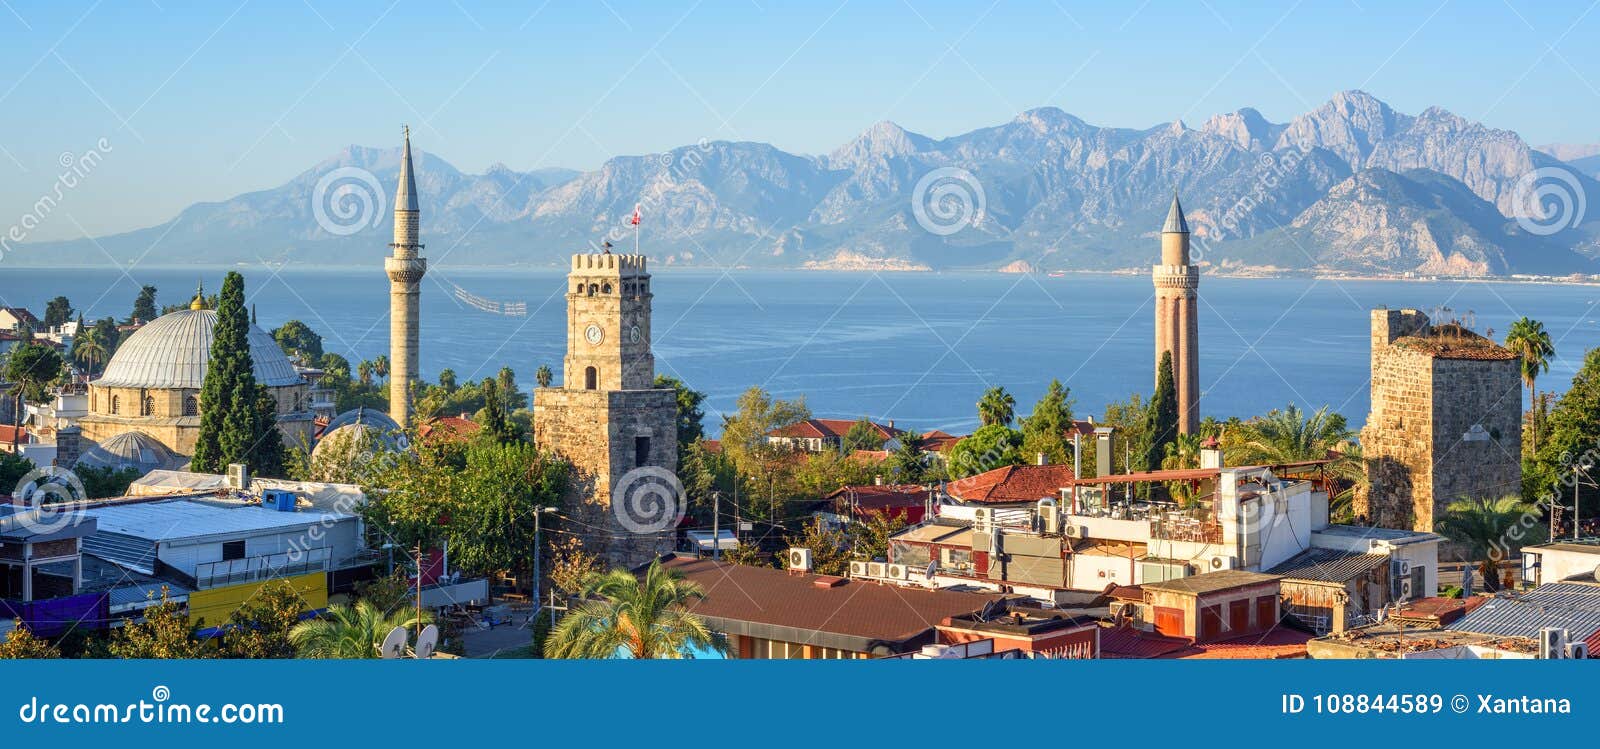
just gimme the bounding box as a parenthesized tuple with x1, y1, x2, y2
(0, 267, 1600, 432)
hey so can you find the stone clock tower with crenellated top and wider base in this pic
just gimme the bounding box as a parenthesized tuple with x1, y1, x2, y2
(533, 253, 685, 563)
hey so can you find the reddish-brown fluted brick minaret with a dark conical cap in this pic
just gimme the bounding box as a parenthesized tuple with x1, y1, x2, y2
(1150, 195, 1200, 434)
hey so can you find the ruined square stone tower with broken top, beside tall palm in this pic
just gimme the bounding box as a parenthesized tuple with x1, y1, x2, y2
(1355, 309, 1522, 531)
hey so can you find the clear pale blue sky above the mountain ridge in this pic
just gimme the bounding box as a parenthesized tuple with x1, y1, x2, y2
(0, 0, 1600, 238)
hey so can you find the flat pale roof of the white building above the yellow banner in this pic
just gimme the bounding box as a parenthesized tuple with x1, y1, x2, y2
(83, 499, 355, 543)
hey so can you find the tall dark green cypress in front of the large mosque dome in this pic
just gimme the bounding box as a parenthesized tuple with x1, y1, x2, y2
(192, 272, 268, 474)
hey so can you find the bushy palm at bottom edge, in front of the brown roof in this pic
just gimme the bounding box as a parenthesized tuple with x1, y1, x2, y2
(544, 560, 725, 659)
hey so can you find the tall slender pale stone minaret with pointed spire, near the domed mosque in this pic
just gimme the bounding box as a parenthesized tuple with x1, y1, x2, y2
(384, 128, 427, 427)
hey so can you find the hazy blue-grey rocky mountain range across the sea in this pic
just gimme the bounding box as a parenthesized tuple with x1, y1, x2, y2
(11, 91, 1600, 275)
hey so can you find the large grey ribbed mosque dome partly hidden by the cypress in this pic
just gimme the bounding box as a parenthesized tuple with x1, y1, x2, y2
(94, 309, 304, 389)
